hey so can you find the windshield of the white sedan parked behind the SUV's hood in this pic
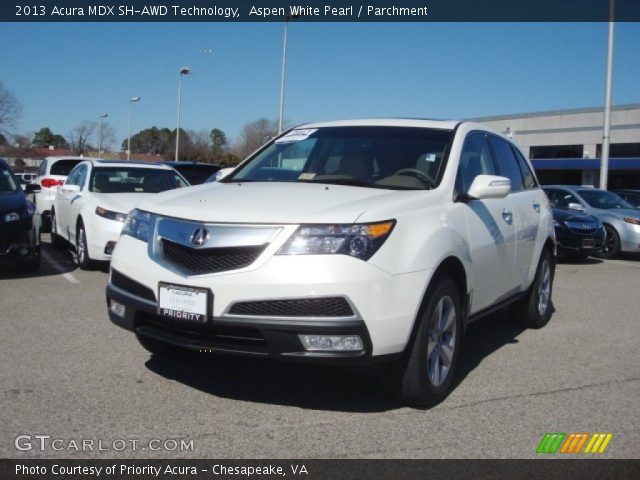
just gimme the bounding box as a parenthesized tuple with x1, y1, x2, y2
(89, 167, 187, 193)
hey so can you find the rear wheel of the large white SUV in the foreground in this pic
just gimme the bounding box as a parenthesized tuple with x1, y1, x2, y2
(511, 248, 553, 328)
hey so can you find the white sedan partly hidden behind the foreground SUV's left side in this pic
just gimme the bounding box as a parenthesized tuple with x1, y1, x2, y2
(51, 160, 188, 269)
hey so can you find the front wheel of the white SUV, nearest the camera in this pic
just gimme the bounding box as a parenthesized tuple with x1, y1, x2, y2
(398, 276, 462, 408)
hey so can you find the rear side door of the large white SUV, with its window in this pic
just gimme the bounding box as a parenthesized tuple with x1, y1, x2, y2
(489, 135, 544, 293)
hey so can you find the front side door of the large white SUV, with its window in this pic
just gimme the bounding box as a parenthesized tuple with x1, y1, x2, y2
(456, 132, 516, 313)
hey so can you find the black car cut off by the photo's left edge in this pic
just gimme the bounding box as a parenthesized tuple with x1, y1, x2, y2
(0, 158, 40, 271)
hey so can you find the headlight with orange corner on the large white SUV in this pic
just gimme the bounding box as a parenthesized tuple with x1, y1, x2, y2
(278, 220, 396, 260)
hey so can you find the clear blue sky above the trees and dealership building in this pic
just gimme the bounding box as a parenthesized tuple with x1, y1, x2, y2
(0, 22, 640, 146)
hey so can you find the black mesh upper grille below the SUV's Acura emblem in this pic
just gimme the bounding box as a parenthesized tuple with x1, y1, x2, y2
(162, 239, 266, 274)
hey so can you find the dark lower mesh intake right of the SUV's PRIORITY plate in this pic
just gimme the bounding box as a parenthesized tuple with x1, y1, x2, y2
(229, 297, 353, 317)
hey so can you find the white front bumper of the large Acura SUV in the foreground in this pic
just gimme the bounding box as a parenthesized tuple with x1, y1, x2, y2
(107, 235, 432, 358)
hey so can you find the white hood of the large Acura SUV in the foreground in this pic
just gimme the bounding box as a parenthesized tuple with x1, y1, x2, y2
(139, 182, 411, 224)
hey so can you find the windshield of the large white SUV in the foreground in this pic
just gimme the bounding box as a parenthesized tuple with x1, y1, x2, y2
(228, 127, 453, 190)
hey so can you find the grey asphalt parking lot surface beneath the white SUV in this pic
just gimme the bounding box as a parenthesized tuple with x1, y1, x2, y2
(0, 237, 640, 458)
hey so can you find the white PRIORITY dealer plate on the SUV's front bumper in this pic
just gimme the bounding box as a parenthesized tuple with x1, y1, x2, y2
(158, 283, 213, 323)
